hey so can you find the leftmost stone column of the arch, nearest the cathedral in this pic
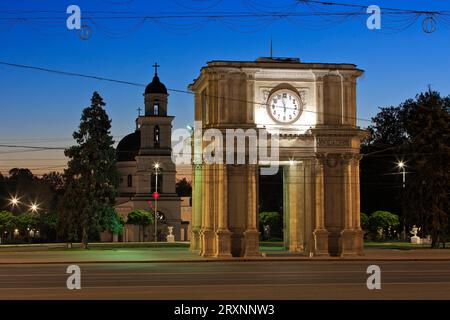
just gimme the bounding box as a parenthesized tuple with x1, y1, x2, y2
(190, 164, 203, 251)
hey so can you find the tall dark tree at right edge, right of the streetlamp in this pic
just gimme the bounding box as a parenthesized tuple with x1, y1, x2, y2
(404, 89, 450, 248)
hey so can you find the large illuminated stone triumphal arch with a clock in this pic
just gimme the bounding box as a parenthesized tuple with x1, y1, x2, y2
(189, 58, 365, 257)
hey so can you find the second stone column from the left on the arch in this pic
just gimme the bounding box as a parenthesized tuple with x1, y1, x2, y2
(200, 164, 214, 257)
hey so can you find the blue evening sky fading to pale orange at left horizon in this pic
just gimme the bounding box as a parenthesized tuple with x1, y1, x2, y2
(0, 0, 450, 173)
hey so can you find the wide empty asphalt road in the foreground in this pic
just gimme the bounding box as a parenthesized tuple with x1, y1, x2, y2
(0, 261, 450, 300)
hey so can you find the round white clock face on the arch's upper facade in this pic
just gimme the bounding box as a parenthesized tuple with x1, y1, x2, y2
(267, 90, 301, 123)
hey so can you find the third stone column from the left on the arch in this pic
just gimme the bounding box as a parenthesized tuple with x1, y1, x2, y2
(215, 164, 231, 258)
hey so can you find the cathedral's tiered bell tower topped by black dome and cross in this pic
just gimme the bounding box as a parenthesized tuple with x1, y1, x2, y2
(133, 63, 180, 239)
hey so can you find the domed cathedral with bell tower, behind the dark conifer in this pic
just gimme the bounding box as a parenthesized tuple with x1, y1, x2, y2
(116, 64, 181, 241)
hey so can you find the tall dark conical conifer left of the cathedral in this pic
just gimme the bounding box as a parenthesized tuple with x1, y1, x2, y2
(60, 92, 119, 248)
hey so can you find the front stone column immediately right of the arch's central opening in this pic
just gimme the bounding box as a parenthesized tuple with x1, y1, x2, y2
(313, 155, 329, 256)
